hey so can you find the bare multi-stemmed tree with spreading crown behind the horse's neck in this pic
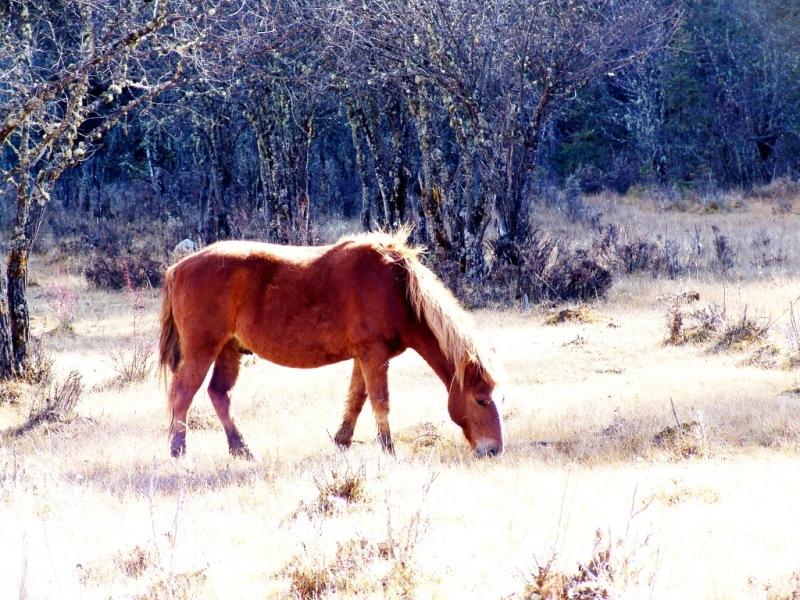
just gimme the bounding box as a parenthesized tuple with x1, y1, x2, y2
(331, 0, 677, 278)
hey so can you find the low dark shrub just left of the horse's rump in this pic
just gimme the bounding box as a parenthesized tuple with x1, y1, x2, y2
(84, 253, 165, 290)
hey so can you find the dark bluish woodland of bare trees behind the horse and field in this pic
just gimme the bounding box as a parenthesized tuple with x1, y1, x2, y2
(0, 0, 800, 378)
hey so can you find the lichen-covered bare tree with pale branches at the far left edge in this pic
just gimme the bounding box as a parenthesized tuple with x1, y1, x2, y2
(0, 0, 206, 377)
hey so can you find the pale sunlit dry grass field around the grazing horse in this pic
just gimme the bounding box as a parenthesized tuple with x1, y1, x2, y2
(0, 199, 800, 599)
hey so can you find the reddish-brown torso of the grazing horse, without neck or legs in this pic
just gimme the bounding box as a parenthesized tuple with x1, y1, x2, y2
(163, 238, 409, 367)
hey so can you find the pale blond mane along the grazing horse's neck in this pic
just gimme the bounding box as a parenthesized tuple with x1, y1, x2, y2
(349, 228, 493, 386)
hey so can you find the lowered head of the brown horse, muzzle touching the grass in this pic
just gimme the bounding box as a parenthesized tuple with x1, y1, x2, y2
(447, 361, 503, 456)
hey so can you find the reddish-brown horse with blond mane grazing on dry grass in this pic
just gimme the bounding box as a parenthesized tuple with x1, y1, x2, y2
(160, 233, 503, 458)
